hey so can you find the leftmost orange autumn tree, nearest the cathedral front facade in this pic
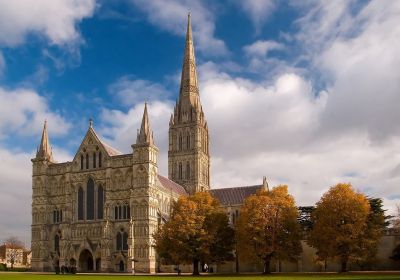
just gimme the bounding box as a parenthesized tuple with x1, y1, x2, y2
(154, 192, 234, 275)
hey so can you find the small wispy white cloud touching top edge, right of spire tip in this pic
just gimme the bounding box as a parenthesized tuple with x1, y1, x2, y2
(235, 0, 276, 33)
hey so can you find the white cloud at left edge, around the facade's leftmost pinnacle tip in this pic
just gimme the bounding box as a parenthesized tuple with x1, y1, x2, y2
(0, 87, 71, 138)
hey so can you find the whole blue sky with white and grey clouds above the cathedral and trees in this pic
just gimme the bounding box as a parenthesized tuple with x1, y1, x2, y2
(0, 0, 400, 245)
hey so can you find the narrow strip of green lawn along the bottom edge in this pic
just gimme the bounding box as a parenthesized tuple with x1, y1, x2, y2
(0, 272, 400, 280)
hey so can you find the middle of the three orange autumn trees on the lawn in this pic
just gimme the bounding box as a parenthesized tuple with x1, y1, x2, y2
(236, 185, 301, 274)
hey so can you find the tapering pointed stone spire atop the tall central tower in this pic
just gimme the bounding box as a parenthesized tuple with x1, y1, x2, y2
(179, 12, 199, 106)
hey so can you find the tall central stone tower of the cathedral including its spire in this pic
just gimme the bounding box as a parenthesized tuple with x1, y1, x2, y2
(168, 13, 210, 194)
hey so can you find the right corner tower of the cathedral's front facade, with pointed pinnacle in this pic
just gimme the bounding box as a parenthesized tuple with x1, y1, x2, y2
(128, 103, 159, 273)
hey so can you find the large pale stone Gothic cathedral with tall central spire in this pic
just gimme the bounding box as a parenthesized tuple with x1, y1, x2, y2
(31, 14, 399, 273)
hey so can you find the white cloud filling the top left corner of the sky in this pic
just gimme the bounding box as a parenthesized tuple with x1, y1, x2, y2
(0, 0, 96, 46)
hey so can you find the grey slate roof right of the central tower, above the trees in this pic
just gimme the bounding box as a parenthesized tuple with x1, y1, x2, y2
(210, 185, 262, 205)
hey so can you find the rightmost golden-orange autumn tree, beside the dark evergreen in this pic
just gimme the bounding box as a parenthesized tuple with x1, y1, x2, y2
(308, 184, 370, 272)
